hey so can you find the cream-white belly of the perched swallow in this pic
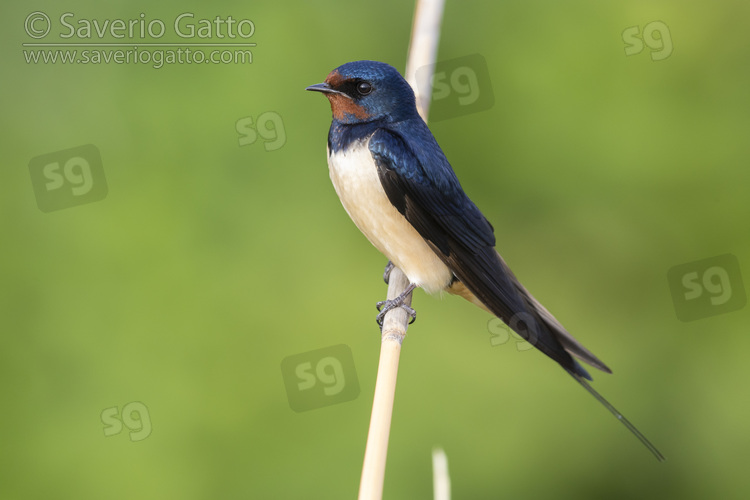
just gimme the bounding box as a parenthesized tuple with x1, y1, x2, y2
(328, 139, 453, 293)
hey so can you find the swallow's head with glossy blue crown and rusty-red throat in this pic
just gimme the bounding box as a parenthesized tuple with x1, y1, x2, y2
(306, 61, 417, 124)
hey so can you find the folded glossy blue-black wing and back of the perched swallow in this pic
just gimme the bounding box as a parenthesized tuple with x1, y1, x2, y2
(369, 124, 610, 379)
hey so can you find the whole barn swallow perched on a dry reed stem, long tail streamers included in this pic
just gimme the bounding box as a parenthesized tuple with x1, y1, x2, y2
(306, 61, 664, 460)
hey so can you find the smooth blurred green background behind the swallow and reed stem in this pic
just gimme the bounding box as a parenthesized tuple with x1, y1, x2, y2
(0, 0, 750, 499)
